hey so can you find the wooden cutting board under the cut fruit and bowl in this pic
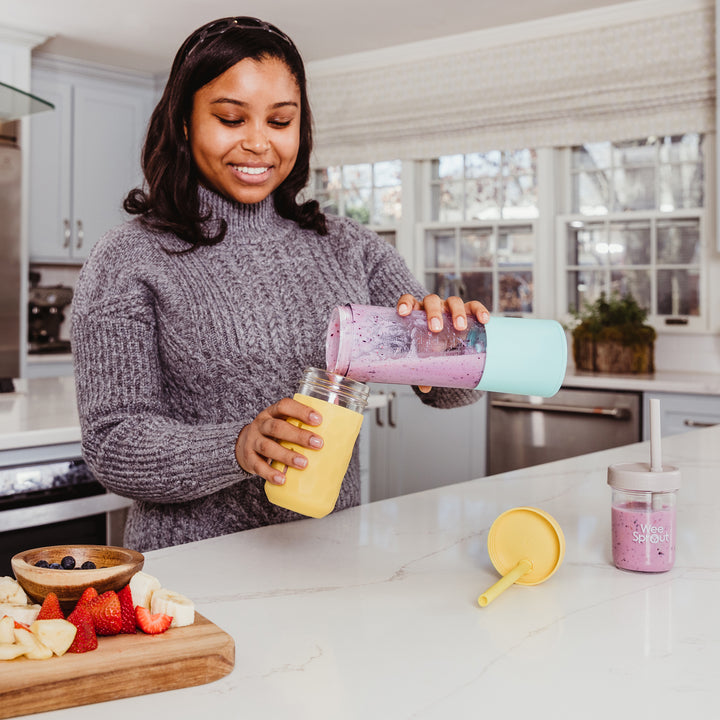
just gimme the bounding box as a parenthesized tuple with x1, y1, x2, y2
(0, 613, 235, 718)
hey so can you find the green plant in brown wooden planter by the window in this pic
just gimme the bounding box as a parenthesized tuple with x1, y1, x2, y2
(572, 293, 656, 373)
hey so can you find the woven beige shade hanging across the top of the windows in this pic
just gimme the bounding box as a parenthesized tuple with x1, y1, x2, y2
(309, 6, 715, 166)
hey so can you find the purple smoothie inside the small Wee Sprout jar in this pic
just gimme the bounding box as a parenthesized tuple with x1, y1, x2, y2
(612, 502, 675, 572)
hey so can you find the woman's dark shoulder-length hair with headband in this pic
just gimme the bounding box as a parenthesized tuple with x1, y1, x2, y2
(123, 17, 327, 249)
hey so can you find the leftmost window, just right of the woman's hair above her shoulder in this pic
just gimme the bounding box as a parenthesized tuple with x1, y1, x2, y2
(313, 160, 402, 245)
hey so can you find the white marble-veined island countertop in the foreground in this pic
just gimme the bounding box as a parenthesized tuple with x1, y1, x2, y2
(16, 427, 720, 720)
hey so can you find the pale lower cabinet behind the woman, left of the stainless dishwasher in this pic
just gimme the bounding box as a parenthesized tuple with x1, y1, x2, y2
(365, 385, 487, 501)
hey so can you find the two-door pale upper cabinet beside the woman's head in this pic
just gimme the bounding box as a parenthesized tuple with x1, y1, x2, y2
(29, 59, 153, 264)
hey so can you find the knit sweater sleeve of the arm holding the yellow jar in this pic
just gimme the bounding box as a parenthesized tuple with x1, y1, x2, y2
(72, 231, 249, 503)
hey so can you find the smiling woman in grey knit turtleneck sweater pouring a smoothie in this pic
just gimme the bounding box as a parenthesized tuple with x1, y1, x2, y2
(72, 17, 487, 551)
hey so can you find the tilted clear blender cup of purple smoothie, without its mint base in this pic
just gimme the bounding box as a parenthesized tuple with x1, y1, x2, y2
(326, 305, 486, 388)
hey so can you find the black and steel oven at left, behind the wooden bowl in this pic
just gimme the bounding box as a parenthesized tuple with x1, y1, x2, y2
(0, 452, 131, 576)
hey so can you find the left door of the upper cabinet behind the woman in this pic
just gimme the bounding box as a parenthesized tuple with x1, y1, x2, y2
(28, 73, 72, 262)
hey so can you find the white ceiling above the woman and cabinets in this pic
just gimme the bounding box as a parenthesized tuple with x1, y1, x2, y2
(0, 0, 632, 73)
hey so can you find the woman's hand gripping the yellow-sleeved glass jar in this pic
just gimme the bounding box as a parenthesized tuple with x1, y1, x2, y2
(235, 398, 323, 485)
